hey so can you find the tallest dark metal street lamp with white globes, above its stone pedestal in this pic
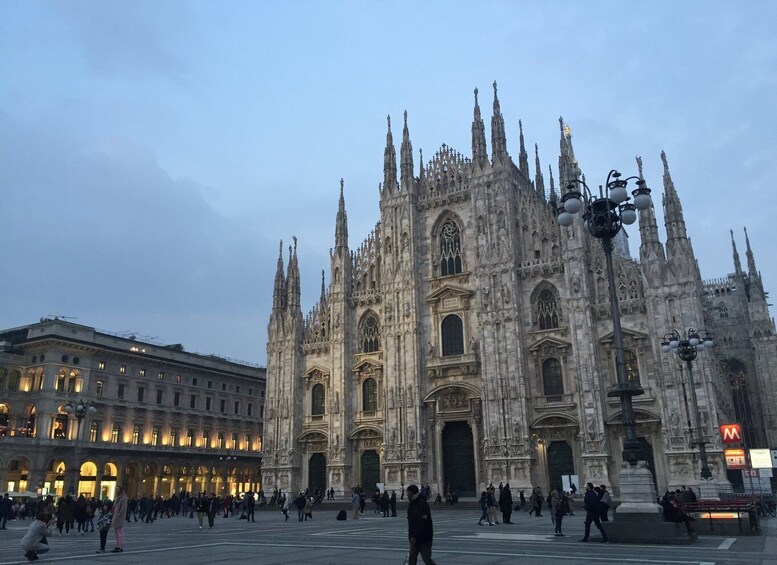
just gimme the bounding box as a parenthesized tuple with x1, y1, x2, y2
(556, 170, 652, 465)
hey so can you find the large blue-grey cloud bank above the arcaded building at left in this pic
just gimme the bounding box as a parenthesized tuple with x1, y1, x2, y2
(0, 114, 277, 360)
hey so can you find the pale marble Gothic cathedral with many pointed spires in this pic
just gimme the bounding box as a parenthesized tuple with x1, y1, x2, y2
(262, 83, 777, 496)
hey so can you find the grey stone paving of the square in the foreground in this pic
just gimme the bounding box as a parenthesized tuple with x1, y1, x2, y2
(0, 503, 777, 565)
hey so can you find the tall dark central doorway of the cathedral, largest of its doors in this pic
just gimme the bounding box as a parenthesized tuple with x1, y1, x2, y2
(442, 422, 477, 496)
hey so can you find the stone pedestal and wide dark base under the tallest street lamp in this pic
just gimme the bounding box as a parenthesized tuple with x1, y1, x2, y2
(602, 461, 696, 545)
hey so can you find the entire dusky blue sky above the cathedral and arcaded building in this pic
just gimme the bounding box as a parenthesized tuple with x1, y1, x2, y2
(0, 0, 777, 364)
